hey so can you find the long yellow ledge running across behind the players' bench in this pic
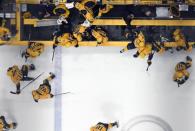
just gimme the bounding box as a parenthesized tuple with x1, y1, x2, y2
(24, 18, 195, 27)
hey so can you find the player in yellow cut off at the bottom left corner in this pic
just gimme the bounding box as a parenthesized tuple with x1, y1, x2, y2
(0, 116, 17, 131)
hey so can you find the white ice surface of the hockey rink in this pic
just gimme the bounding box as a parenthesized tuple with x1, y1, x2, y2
(0, 46, 195, 131)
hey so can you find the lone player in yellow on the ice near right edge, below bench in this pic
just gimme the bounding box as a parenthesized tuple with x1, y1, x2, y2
(173, 56, 192, 87)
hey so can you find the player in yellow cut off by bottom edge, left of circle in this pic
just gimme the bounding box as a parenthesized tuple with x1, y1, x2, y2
(90, 122, 119, 131)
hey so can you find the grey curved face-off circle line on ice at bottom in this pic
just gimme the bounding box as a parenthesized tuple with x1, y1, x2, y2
(121, 115, 173, 131)
